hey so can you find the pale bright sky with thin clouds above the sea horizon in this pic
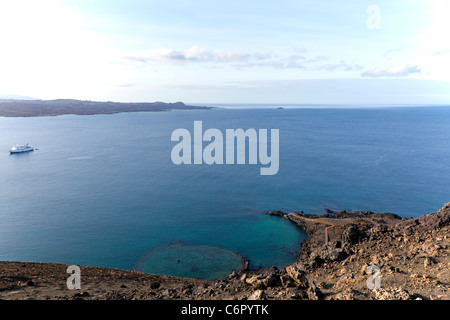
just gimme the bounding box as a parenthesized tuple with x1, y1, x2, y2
(0, 0, 450, 104)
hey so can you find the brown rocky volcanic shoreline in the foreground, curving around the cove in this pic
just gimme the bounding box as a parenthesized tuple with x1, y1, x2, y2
(0, 203, 450, 300)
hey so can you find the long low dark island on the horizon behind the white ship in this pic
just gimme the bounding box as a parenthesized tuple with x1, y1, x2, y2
(0, 99, 212, 117)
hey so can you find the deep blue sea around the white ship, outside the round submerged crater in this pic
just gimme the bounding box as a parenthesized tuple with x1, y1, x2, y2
(0, 107, 450, 278)
